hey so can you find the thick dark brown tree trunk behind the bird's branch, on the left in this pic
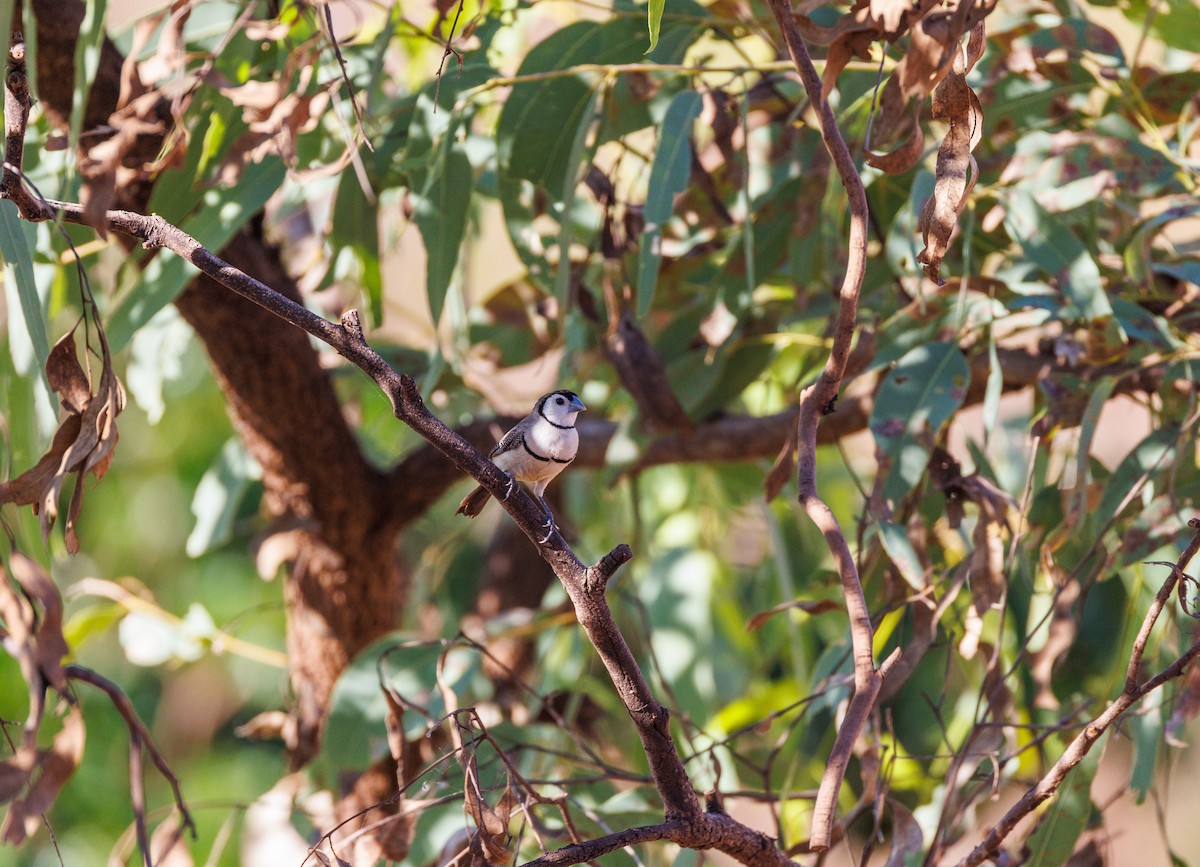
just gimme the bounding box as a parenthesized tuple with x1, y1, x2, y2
(29, 0, 406, 764)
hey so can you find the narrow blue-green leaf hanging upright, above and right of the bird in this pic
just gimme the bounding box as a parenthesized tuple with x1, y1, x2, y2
(637, 91, 703, 316)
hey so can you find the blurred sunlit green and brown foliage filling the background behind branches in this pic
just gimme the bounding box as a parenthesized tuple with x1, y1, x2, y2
(0, 0, 1200, 865)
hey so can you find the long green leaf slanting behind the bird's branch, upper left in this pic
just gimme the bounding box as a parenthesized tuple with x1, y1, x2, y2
(108, 157, 287, 352)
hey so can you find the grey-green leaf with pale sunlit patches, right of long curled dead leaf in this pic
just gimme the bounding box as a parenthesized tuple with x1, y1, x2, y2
(1004, 190, 1112, 319)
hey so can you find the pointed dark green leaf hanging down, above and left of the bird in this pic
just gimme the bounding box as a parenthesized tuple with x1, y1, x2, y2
(413, 143, 473, 323)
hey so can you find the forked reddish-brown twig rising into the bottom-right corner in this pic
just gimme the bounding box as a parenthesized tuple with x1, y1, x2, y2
(959, 518, 1200, 867)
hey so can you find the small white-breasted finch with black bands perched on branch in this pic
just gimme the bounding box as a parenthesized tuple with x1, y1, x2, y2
(455, 389, 587, 543)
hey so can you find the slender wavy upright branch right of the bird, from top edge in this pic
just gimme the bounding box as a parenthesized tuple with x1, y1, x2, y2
(770, 0, 899, 851)
